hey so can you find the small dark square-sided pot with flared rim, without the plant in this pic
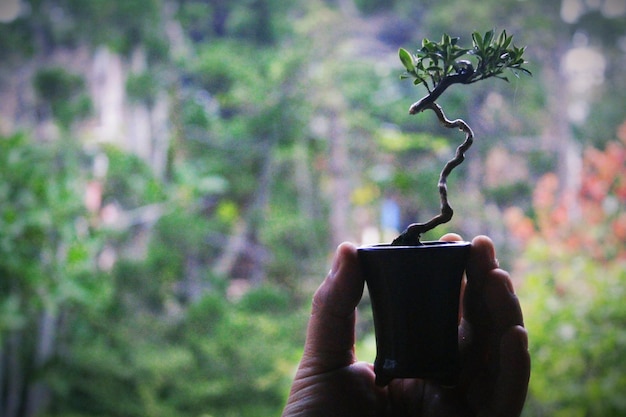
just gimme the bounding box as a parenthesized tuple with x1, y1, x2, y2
(358, 242, 470, 386)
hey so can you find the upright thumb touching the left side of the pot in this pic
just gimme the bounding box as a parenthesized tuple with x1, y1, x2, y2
(299, 243, 364, 377)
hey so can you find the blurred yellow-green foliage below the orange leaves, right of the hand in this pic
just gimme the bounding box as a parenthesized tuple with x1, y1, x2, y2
(519, 242, 626, 417)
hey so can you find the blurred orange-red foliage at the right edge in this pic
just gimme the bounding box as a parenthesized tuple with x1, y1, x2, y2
(505, 122, 626, 260)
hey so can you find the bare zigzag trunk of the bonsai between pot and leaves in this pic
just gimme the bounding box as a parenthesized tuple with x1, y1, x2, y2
(391, 101, 474, 245)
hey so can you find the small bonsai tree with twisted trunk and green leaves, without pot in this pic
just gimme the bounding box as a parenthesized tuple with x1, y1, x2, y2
(392, 30, 531, 245)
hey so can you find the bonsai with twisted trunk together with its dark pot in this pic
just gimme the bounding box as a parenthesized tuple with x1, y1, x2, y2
(358, 30, 530, 385)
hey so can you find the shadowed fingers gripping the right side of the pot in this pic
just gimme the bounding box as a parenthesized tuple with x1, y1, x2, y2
(459, 236, 530, 416)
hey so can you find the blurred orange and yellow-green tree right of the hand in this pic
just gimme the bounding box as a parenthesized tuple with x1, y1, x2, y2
(508, 125, 626, 416)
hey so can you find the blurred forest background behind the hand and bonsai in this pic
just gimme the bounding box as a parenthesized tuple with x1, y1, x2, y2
(0, 0, 626, 417)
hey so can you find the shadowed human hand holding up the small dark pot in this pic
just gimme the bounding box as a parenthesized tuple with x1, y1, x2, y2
(283, 234, 530, 417)
